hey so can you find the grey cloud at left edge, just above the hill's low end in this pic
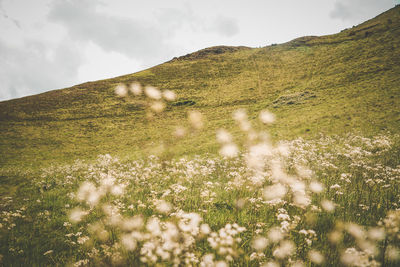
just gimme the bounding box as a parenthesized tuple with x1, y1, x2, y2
(0, 37, 82, 99)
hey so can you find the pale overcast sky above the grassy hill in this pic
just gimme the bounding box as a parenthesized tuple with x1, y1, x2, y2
(0, 0, 400, 101)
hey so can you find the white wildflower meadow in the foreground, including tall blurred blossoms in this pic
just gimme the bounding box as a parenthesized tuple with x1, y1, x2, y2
(0, 82, 400, 267)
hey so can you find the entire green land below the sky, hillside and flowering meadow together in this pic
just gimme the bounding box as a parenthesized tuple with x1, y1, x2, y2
(0, 7, 400, 266)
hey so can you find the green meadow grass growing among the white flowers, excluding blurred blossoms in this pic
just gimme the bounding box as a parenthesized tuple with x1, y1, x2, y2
(0, 135, 400, 266)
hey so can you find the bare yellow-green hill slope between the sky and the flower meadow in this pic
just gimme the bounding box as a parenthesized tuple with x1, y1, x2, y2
(0, 7, 400, 170)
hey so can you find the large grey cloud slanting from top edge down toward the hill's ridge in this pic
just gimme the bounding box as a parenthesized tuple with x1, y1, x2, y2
(49, 0, 171, 64)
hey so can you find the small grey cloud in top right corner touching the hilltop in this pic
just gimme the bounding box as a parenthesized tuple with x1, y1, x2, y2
(330, 0, 394, 22)
